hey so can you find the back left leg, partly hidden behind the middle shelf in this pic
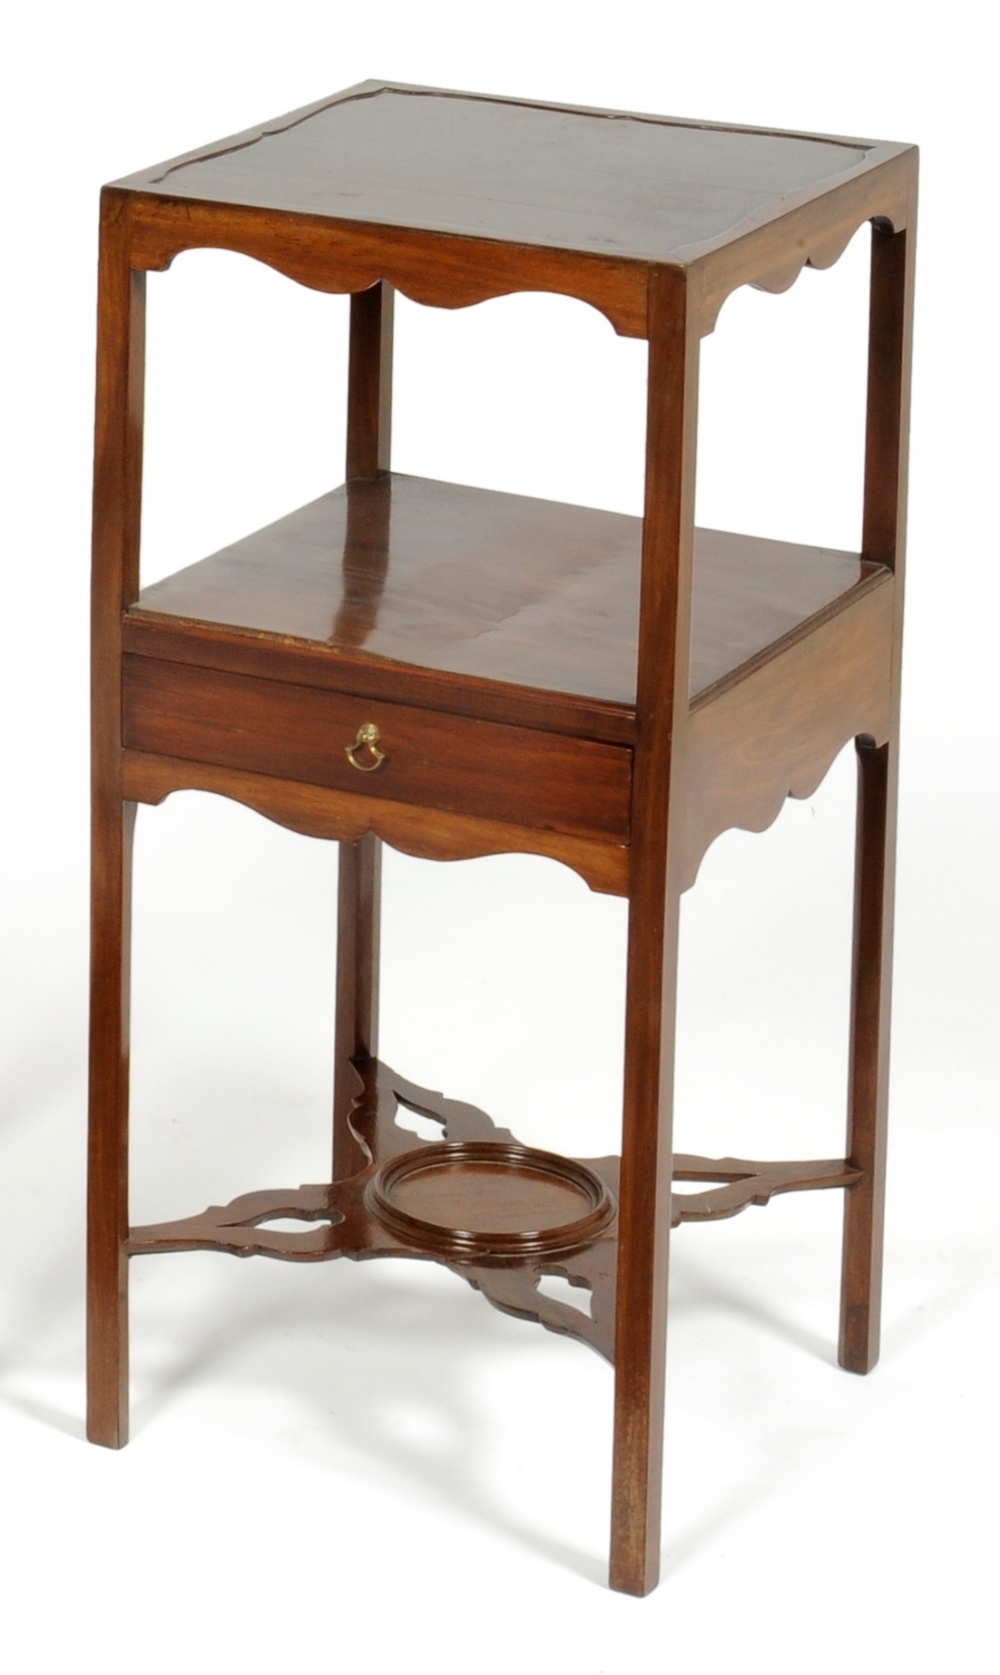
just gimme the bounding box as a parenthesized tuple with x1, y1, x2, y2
(333, 280, 394, 1181)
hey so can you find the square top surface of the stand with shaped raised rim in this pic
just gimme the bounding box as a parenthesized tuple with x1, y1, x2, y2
(116, 82, 908, 263)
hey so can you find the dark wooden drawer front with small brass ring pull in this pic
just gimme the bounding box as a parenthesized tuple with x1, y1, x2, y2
(122, 655, 631, 843)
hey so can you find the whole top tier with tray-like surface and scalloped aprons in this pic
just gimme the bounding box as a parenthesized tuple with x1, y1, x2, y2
(109, 82, 913, 337)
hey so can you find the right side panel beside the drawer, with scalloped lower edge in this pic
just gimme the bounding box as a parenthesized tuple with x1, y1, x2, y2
(683, 576, 894, 888)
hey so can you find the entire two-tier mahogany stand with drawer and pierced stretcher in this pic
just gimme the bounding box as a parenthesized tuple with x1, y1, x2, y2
(89, 82, 916, 1593)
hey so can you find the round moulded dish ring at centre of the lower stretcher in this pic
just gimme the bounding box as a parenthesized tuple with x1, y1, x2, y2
(365, 1141, 615, 1256)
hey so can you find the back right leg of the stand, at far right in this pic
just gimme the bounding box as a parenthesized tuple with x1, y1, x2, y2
(839, 202, 916, 1372)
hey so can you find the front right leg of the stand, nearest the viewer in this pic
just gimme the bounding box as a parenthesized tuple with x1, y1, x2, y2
(610, 268, 698, 1595)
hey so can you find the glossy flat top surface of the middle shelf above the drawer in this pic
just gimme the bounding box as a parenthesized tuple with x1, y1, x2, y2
(129, 474, 884, 709)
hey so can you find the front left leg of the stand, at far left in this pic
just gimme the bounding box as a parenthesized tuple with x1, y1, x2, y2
(87, 191, 146, 1449)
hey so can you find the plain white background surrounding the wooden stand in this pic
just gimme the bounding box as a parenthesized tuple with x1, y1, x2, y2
(0, 0, 1000, 1675)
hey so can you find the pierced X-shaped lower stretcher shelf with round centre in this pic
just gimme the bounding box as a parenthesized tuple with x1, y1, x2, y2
(126, 1060, 859, 1360)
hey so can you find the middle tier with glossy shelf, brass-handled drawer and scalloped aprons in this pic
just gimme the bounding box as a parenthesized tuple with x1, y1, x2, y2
(122, 474, 896, 893)
